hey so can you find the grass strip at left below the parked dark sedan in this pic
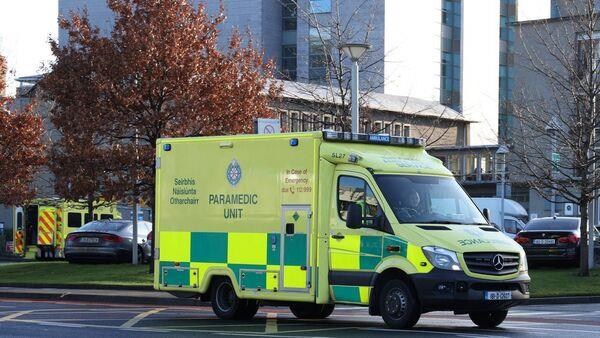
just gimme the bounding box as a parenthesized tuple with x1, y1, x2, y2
(0, 262, 152, 286)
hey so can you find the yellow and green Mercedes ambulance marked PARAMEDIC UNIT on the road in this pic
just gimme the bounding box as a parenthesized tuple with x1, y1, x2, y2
(154, 131, 530, 328)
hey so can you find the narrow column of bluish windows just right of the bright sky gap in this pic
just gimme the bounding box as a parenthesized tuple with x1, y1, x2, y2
(498, 0, 517, 140)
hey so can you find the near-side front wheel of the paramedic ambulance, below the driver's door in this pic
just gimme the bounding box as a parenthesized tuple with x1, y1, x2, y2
(378, 279, 421, 329)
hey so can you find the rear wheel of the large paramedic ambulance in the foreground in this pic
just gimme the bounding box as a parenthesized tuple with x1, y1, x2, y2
(210, 278, 258, 319)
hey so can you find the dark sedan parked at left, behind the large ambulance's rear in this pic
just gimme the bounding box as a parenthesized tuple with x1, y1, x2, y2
(65, 220, 152, 263)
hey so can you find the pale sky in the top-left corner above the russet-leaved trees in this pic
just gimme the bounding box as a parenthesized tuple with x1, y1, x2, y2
(0, 0, 58, 95)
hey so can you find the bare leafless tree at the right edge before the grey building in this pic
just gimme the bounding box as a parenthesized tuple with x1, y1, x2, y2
(508, 0, 600, 276)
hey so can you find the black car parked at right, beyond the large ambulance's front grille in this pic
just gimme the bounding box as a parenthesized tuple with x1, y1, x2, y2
(515, 217, 581, 264)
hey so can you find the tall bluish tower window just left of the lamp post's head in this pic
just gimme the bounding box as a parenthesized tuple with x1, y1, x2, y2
(308, 27, 331, 83)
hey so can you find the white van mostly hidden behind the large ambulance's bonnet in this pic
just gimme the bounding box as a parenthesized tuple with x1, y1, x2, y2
(473, 197, 529, 238)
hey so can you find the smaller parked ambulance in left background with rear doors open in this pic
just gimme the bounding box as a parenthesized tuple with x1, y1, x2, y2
(13, 198, 121, 259)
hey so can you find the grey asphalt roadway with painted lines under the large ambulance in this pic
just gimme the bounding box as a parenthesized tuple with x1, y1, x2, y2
(0, 299, 600, 338)
